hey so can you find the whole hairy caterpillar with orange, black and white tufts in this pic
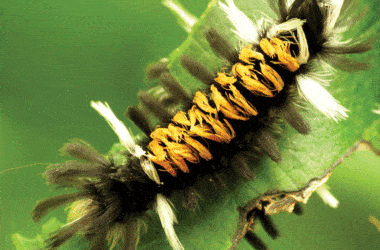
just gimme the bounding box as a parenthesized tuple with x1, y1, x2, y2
(26, 0, 373, 249)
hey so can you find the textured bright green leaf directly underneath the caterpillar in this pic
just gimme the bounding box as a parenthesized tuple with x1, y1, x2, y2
(134, 1, 380, 250)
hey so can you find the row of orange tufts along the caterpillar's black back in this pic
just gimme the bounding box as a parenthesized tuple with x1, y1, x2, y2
(148, 34, 300, 176)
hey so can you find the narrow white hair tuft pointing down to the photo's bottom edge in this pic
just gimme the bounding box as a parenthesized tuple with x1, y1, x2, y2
(156, 194, 184, 250)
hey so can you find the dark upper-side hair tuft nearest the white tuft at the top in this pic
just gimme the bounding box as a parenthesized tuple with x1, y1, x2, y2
(206, 28, 239, 64)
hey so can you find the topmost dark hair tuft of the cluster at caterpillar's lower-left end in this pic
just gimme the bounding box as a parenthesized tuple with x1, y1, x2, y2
(60, 139, 110, 165)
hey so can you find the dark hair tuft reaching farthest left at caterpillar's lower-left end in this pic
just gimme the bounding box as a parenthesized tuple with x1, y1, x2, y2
(32, 192, 85, 222)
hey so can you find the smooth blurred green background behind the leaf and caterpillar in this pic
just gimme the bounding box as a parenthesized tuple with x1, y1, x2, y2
(0, 0, 380, 250)
